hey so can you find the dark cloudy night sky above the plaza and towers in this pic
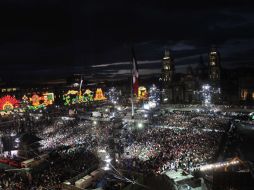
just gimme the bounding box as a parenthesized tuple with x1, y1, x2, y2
(0, 0, 254, 80)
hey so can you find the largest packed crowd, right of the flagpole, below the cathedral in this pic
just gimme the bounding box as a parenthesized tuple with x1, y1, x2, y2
(120, 112, 229, 173)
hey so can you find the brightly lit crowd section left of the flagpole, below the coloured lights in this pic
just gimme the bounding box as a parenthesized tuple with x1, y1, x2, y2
(37, 119, 110, 151)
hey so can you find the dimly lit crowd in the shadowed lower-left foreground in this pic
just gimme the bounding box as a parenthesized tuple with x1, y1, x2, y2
(0, 146, 98, 190)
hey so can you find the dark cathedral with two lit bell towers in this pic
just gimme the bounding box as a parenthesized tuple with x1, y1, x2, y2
(160, 47, 221, 104)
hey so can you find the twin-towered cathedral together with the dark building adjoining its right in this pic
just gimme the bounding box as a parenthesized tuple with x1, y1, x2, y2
(160, 47, 254, 105)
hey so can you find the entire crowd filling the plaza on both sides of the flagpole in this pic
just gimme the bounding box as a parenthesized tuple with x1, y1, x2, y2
(0, 104, 246, 190)
